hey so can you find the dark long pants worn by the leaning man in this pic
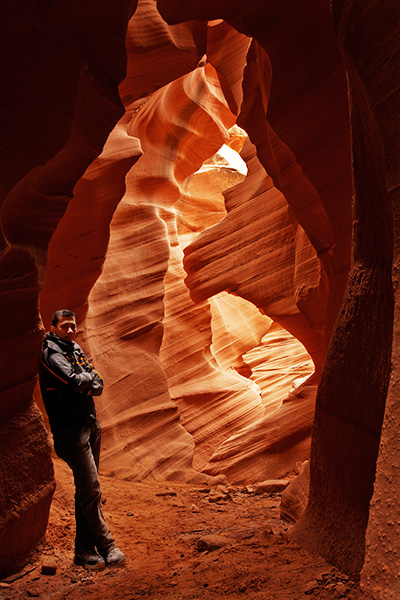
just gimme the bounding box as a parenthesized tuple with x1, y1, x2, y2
(53, 421, 115, 553)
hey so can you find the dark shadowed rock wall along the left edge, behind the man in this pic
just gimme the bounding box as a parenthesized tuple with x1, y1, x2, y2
(0, 2, 137, 577)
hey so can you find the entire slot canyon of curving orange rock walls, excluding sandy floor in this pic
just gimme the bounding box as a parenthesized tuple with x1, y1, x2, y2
(0, 0, 400, 600)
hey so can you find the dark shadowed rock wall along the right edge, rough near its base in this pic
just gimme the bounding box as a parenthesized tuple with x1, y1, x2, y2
(292, 2, 400, 584)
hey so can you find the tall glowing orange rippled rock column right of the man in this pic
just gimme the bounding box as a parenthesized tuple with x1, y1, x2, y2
(84, 58, 239, 479)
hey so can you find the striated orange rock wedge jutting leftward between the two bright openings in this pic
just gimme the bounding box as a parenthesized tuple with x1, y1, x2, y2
(184, 137, 323, 367)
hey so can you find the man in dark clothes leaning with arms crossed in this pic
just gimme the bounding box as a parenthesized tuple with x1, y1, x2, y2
(39, 310, 126, 569)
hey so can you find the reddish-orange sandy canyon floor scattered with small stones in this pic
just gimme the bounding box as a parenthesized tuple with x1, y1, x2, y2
(0, 460, 368, 600)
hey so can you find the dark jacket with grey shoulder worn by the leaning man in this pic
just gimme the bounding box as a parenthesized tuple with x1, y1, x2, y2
(39, 332, 103, 433)
